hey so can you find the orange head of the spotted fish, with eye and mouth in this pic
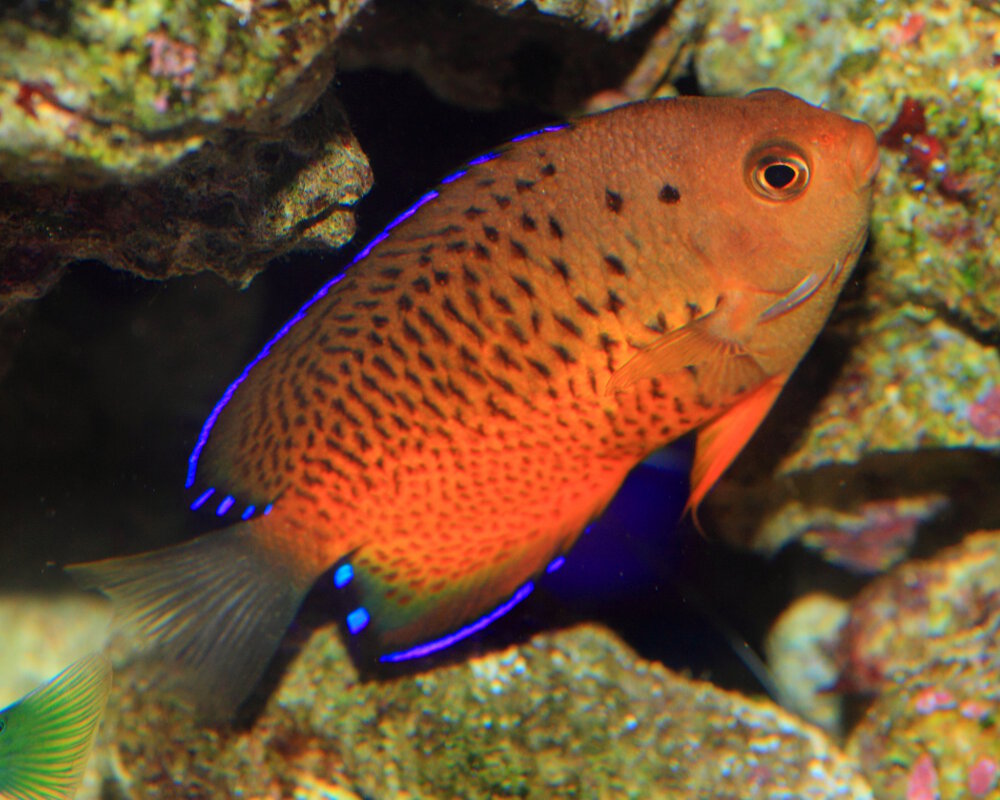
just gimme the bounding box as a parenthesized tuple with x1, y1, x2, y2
(672, 89, 879, 371)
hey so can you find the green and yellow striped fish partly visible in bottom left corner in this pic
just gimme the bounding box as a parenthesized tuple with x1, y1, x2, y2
(0, 653, 111, 800)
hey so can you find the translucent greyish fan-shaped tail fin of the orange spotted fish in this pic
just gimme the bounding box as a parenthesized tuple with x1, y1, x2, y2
(66, 520, 316, 718)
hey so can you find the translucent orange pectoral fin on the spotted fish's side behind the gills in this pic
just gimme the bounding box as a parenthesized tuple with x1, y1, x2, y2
(606, 311, 767, 398)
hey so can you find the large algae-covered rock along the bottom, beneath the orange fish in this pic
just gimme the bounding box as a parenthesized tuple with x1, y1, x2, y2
(95, 626, 871, 800)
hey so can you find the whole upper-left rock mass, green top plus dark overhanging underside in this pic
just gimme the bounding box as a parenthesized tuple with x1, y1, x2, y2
(0, 0, 372, 311)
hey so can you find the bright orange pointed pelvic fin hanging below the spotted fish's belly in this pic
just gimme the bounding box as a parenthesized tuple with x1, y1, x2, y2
(685, 375, 788, 523)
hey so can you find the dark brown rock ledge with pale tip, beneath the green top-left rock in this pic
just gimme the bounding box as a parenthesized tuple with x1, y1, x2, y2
(0, 90, 372, 309)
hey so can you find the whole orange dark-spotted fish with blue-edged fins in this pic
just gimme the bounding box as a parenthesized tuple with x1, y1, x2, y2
(68, 89, 879, 714)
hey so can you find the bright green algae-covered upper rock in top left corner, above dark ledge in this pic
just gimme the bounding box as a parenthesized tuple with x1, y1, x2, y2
(0, 0, 372, 186)
